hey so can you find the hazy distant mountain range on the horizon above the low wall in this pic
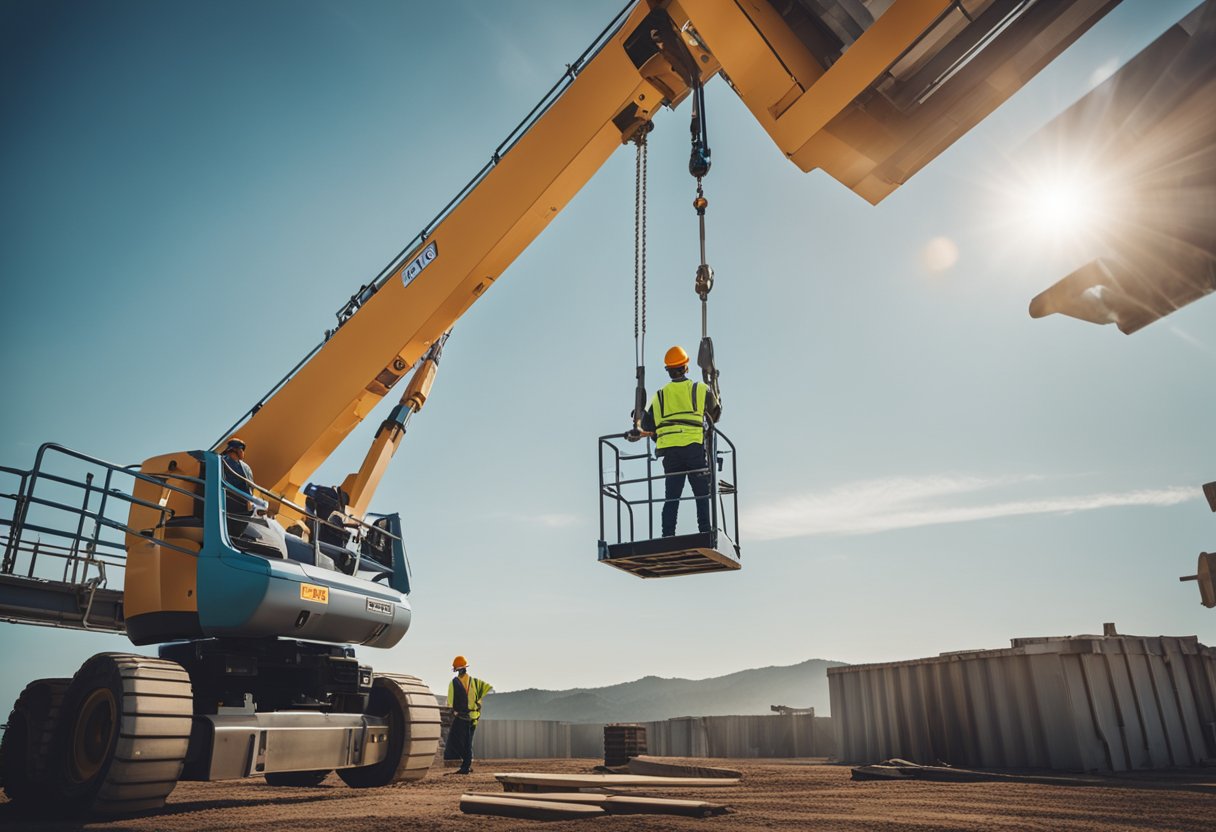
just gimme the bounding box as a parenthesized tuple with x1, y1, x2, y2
(484, 659, 844, 723)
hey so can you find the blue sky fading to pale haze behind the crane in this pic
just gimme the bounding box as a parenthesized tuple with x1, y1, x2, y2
(0, 0, 1216, 708)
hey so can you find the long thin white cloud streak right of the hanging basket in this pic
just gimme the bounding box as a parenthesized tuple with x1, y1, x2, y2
(743, 476, 1198, 540)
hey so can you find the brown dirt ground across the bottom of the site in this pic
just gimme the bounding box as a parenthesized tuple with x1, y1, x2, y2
(0, 760, 1216, 832)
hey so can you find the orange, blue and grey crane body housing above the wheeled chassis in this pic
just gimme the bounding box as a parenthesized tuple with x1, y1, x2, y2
(125, 451, 410, 647)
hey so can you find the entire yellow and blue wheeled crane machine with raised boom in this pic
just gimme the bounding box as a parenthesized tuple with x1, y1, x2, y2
(0, 0, 1206, 813)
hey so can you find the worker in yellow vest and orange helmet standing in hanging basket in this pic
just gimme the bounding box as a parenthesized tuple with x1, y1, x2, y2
(642, 347, 722, 538)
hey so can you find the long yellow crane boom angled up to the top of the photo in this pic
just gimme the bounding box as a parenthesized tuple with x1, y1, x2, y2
(206, 0, 1118, 513)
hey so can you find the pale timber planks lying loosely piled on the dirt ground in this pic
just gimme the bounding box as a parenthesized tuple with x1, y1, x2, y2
(460, 758, 739, 820)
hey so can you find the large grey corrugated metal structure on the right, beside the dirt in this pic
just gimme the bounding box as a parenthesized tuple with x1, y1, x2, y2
(828, 636, 1216, 771)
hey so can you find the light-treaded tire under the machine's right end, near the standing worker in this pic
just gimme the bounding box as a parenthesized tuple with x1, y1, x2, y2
(338, 673, 440, 788)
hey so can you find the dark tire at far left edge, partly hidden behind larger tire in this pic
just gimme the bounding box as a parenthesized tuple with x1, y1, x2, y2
(0, 679, 72, 806)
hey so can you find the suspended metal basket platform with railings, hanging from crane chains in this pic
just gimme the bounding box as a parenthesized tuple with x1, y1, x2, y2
(599, 428, 743, 578)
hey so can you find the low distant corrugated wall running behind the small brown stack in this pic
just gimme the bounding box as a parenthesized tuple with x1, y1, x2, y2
(473, 714, 835, 759)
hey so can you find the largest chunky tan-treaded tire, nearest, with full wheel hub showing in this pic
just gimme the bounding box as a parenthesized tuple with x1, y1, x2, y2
(51, 653, 193, 815)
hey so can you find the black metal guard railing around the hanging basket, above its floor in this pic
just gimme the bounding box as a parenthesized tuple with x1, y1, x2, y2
(598, 427, 739, 553)
